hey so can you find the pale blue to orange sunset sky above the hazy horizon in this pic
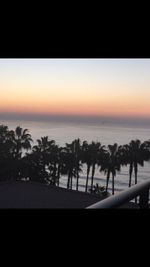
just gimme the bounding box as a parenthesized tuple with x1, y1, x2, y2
(0, 59, 150, 121)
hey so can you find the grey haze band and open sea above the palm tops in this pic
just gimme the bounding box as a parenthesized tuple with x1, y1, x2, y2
(0, 114, 150, 145)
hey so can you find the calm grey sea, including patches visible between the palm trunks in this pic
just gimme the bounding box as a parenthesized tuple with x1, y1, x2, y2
(0, 120, 150, 195)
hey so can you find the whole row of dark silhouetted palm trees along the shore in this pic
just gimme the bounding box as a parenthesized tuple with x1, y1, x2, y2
(0, 125, 150, 194)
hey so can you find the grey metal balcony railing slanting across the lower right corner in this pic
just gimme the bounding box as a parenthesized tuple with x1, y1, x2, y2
(87, 180, 150, 209)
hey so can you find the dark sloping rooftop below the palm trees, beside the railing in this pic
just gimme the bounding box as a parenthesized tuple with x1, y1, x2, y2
(0, 181, 106, 209)
